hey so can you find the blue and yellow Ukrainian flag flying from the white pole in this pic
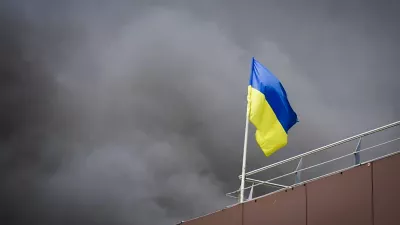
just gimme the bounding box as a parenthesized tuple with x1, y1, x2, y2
(247, 58, 298, 157)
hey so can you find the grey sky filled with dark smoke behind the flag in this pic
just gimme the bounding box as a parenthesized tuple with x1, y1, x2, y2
(0, 0, 400, 225)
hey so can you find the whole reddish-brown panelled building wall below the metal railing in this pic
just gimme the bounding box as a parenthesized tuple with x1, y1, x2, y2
(183, 154, 400, 225)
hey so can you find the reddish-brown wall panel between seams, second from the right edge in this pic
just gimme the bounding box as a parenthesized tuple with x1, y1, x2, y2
(307, 165, 372, 225)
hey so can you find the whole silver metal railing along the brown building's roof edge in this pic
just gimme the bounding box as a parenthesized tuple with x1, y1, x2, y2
(226, 121, 400, 198)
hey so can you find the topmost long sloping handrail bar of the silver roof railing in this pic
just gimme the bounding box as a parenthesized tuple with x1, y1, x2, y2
(239, 121, 400, 178)
